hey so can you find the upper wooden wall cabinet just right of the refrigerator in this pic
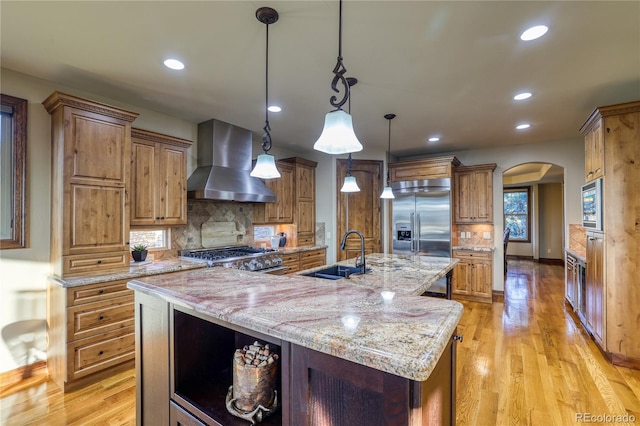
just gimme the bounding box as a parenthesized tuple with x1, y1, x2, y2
(453, 164, 496, 223)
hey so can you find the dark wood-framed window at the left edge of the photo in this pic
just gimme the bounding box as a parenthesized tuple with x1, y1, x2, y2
(0, 95, 27, 249)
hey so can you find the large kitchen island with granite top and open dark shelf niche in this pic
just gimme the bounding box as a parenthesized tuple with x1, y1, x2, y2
(128, 254, 462, 425)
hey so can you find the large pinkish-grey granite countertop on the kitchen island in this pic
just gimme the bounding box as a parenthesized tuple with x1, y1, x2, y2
(128, 254, 463, 381)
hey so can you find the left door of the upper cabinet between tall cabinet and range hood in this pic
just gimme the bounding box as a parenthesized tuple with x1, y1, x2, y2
(131, 142, 159, 225)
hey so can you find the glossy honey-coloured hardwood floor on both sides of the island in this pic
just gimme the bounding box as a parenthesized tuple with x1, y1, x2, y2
(0, 260, 640, 426)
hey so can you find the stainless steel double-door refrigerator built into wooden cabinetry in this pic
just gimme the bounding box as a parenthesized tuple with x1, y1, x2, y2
(392, 179, 451, 299)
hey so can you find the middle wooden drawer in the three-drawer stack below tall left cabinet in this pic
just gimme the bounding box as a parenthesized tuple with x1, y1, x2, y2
(67, 294, 134, 342)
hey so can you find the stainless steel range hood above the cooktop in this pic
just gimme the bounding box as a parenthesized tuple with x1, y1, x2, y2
(187, 120, 276, 203)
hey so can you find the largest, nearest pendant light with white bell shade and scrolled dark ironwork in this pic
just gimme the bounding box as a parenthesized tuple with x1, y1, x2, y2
(313, 0, 362, 154)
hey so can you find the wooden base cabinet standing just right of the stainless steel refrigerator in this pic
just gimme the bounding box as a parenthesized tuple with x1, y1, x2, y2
(452, 250, 493, 303)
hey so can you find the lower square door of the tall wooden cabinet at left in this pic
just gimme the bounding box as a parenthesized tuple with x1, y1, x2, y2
(63, 185, 129, 255)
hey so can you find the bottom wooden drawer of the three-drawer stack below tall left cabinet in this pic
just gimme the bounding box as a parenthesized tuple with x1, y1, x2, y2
(67, 325, 135, 381)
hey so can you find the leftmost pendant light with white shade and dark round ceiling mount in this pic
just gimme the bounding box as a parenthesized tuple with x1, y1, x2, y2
(251, 7, 280, 179)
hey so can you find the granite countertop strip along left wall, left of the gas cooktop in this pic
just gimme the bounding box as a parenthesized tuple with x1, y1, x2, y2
(49, 259, 207, 287)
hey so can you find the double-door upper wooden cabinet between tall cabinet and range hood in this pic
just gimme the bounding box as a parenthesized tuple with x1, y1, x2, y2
(131, 129, 191, 226)
